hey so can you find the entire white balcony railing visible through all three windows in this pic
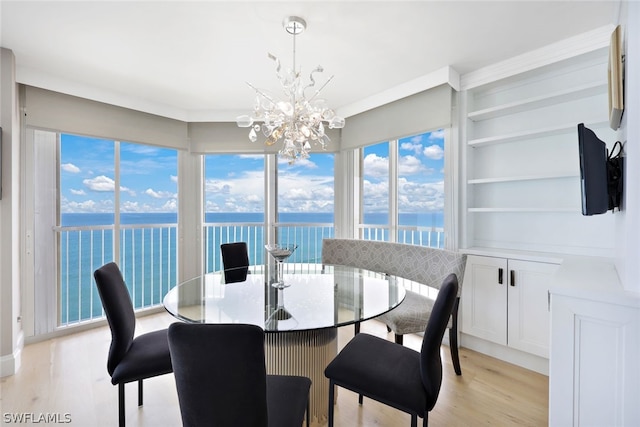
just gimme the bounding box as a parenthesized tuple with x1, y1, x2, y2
(55, 223, 444, 326)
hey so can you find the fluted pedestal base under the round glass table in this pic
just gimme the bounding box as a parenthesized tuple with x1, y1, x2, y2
(265, 328, 338, 423)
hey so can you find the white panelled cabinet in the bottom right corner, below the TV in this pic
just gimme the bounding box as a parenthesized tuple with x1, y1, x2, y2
(549, 260, 640, 427)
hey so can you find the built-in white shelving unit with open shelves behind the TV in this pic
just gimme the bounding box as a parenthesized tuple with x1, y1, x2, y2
(460, 48, 615, 256)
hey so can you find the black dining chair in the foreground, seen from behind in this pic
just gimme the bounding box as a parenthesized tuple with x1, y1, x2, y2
(169, 323, 311, 427)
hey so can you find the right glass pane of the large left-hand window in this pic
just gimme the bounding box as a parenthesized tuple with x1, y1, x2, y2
(116, 142, 178, 308)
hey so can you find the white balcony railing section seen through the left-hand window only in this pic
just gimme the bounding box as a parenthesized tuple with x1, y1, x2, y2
(55, 224, 178, 326)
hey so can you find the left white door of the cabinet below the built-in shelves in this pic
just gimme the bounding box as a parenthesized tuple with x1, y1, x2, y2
(461, 255, 507, 345)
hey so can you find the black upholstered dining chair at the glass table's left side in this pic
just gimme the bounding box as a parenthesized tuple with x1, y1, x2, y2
(93, 262, 172, 427)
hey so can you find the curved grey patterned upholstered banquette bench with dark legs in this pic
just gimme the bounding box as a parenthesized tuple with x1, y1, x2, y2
(322, 239, 466, 375)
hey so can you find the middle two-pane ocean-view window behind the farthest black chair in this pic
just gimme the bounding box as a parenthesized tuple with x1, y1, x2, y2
(204, 153, 334, 271)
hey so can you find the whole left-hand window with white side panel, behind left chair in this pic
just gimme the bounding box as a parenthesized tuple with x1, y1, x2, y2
(30, 131, 178, 334)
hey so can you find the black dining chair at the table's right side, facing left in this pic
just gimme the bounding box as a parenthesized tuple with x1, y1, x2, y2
(324, 274, 458, 427)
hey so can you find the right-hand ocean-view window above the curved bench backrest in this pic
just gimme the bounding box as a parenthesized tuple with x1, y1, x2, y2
(360, 130, 445, 247)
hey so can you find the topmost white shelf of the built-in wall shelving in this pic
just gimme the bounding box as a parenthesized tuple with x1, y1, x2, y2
(467, 83, 607, 122)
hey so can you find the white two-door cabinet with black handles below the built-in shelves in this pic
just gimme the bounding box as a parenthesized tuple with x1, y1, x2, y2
(461, 255, 558, 358)
